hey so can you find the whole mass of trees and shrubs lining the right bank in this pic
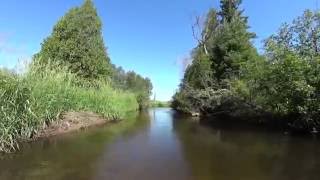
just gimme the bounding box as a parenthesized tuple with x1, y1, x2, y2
(172, 0, 320, 131)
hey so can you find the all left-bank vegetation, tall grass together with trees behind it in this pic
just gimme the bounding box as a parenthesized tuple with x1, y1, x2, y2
(0, 0, 152, 153)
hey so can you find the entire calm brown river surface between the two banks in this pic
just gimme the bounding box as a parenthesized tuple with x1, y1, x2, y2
(0, 109, 320, 180)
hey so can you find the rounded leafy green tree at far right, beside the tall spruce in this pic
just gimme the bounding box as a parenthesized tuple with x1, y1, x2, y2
(259, 10, 320, 129)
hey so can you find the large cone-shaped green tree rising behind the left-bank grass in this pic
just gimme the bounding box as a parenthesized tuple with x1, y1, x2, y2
(35, 0, 111, 79)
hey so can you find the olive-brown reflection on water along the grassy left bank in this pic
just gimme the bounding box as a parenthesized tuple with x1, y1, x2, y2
(0, 113, 149, 180)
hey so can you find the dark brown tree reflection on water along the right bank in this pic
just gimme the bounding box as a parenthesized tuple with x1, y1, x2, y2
(173, 115, 320, 180)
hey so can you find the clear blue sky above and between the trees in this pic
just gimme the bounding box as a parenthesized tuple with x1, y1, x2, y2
(0, 0, 320, 100)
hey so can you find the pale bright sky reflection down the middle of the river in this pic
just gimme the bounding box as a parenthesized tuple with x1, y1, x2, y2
(95, 109, 190, 180)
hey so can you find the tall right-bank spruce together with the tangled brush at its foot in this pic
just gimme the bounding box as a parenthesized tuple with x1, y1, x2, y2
(172, 0, 259, 112)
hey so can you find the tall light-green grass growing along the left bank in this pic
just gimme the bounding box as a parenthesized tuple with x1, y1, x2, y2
(0, 62, 138, 152)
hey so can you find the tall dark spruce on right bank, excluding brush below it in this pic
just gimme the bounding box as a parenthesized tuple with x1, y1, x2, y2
(208, 0, 258, 82)
